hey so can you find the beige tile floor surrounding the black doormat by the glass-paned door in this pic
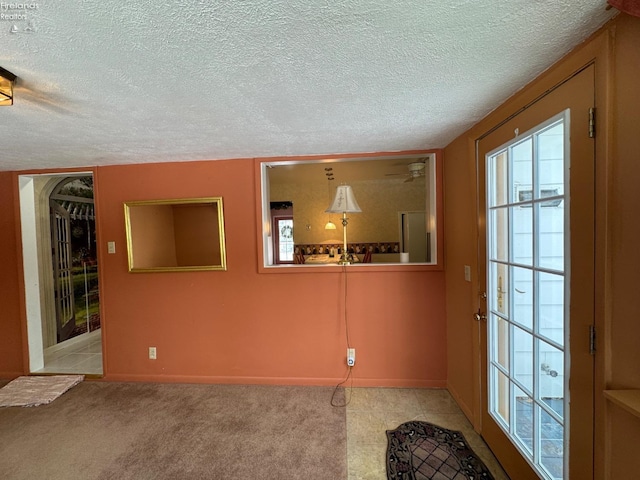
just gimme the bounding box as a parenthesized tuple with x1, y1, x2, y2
(346, 388, 509, 480)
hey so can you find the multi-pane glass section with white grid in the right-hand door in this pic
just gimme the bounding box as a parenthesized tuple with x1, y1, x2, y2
(486, 111, 569, 480)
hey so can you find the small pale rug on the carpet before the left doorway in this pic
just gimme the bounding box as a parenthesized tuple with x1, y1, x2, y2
(0, 375, 84, 407)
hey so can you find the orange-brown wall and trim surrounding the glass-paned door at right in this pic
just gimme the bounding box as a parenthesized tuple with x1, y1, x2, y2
(444, 14, 640, 480)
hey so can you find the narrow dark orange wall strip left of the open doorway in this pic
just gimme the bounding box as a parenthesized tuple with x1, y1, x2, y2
(0, 172, 23, 378)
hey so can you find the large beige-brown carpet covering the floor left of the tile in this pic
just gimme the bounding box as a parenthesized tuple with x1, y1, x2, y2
(0, 382, 347, 480)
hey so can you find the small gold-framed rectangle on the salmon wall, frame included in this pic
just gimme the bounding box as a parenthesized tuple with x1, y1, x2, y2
(124, 197, 227, 272)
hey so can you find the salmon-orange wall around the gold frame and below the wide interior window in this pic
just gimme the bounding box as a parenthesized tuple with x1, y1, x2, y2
(95, 159, 446, 386)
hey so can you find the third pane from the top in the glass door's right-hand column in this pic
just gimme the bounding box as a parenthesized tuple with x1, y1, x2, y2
(536, 272, 565, 345)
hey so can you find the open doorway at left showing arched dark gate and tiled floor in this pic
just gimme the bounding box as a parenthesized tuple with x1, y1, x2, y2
(19, 172, 103, 375)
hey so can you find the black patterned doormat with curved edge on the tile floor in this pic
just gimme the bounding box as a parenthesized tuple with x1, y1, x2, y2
(387, 421, 493, 480)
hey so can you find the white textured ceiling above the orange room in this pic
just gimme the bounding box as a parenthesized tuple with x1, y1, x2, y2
(0, 0, 615, 170)
